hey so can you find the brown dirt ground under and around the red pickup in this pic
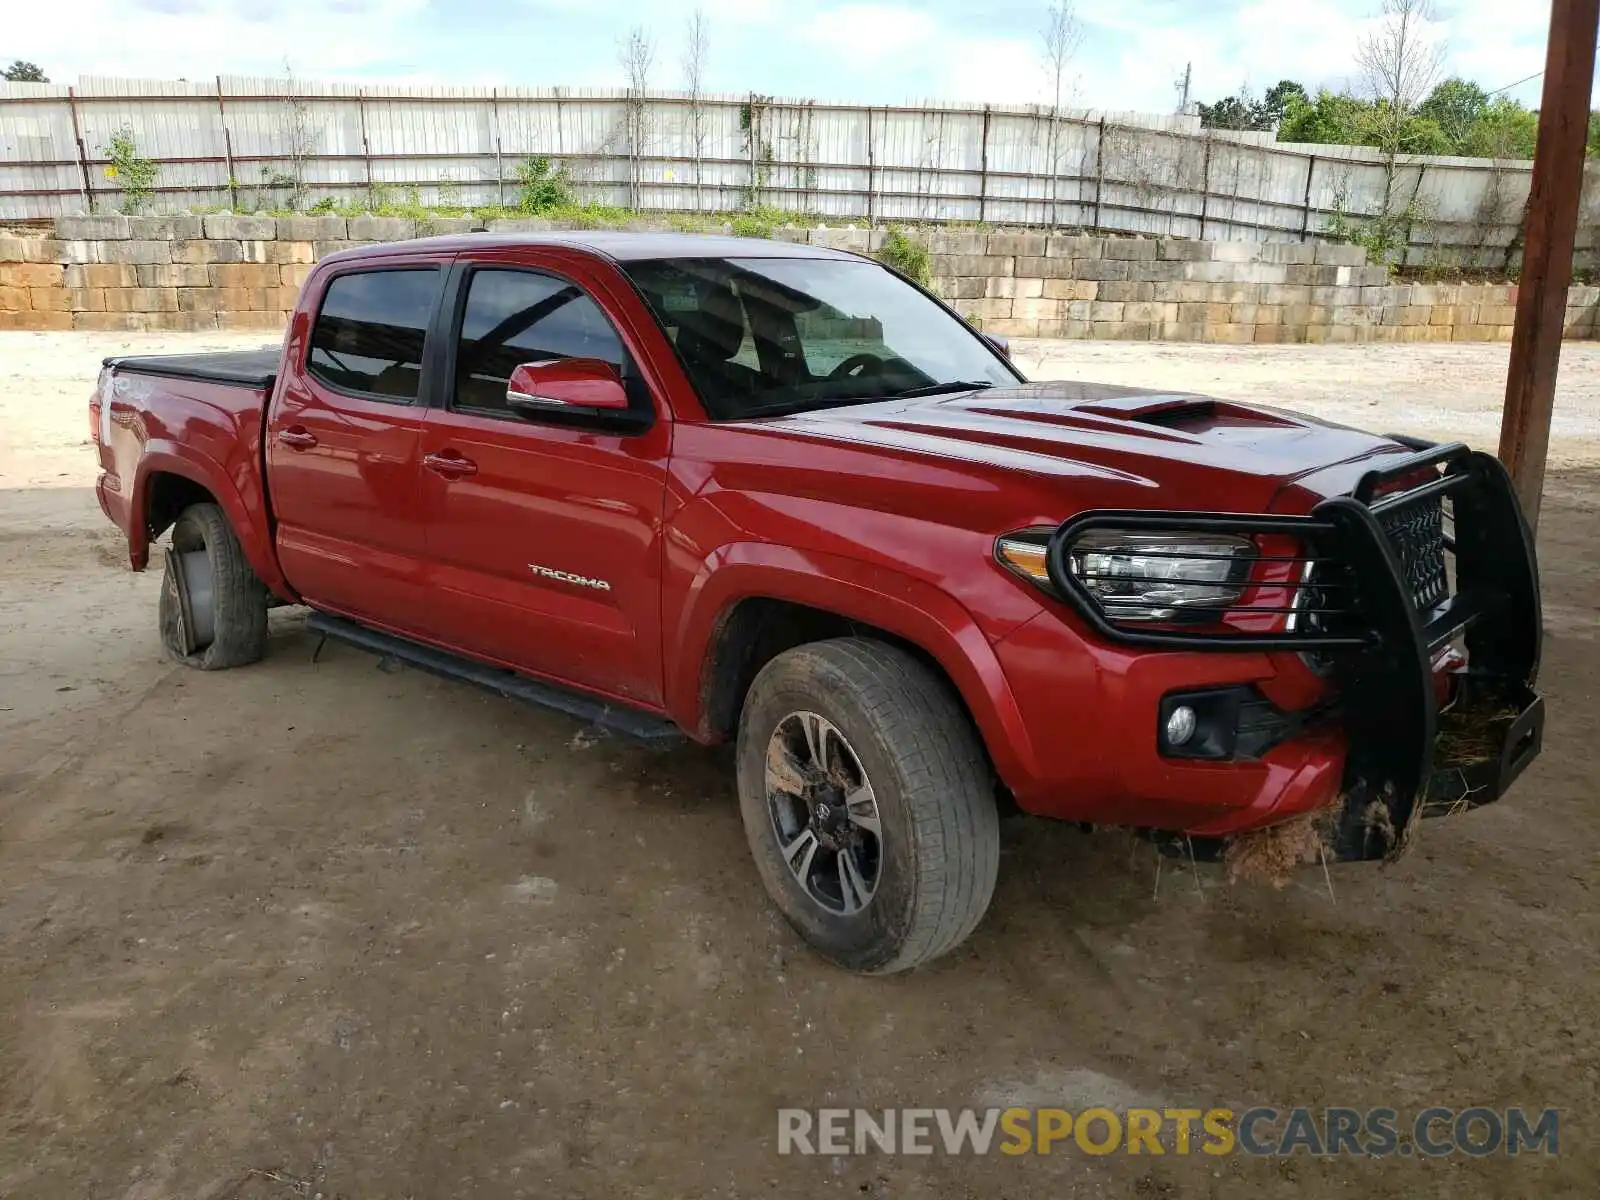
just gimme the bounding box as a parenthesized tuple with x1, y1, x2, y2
(0, 334, 1600, 1200)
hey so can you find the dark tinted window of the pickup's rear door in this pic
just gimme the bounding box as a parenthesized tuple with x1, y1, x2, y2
(306, 267, 442, 405)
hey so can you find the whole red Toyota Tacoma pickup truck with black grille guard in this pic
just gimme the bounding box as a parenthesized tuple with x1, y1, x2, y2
(91, 234, 1544, 973)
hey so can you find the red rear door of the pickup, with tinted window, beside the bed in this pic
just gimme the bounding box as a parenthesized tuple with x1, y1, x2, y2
(266, 256, 448, 634)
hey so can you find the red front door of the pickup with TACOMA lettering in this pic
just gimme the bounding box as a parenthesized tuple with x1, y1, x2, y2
(422, 250, 670, 704)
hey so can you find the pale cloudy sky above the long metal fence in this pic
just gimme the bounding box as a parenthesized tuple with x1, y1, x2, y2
(0, 0, 1574, 112)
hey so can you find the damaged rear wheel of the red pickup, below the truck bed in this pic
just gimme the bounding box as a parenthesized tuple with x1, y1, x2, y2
(160, 504, 267, 670)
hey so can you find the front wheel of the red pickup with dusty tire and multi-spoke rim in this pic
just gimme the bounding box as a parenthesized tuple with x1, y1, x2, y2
(738, 638, 1000, 974)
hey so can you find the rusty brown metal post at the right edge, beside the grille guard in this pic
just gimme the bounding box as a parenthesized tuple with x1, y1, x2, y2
(1499, 0, 1600, 526)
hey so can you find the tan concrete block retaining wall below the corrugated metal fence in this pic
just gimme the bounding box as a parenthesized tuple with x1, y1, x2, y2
(0, 214, 1600, 344)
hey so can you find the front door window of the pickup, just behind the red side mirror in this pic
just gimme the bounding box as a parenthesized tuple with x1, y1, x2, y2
(451, 269, 624, 416)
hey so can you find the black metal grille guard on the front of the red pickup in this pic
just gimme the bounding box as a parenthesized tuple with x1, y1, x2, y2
(1046, 438, 1544, 861)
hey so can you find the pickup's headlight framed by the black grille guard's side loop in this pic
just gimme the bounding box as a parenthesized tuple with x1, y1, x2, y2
(1067, 530, 1256, 621)
